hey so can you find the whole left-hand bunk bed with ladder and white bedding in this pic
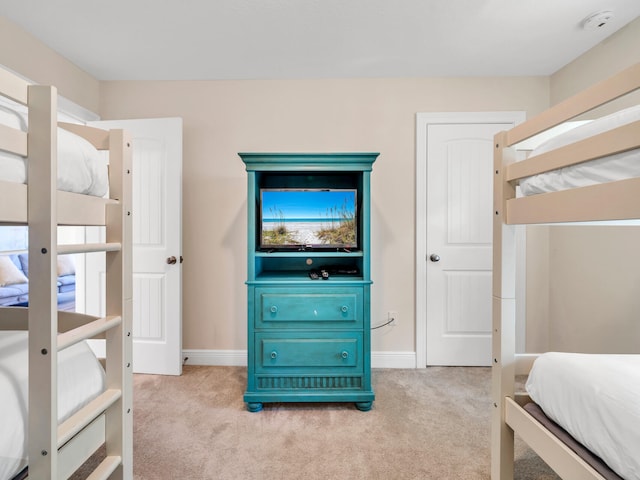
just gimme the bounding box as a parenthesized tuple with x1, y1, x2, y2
(0, 69, 133, 480)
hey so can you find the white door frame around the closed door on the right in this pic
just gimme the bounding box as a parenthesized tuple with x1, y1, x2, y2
(415, 111, 526, 368)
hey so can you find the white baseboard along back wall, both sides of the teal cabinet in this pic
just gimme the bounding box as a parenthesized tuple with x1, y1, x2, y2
(182, 350, 416, 368)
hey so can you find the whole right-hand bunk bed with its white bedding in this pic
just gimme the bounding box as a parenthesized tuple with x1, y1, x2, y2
(491, 64, 640, 480)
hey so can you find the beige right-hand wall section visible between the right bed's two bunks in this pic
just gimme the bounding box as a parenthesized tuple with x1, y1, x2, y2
(549, 227, 640, 353)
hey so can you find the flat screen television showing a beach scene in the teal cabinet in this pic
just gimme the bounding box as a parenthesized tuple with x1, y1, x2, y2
(259, 188, 358, 250)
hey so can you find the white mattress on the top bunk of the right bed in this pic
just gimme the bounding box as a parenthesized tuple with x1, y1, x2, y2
(520, 105, 640, 196)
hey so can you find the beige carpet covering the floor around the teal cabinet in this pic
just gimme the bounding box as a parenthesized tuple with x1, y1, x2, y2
(75, 366, 558, 480)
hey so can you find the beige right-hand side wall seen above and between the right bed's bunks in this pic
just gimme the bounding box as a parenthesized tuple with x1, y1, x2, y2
(527, 19, 640, 353)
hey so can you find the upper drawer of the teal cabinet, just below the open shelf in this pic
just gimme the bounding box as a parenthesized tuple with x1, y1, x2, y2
(255, 287, 363, 328)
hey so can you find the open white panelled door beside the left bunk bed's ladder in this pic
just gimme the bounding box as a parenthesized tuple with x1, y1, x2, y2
(86, 118, 182, 375)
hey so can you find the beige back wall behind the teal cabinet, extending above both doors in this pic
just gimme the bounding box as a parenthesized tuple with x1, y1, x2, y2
(101, 78, 549, 352)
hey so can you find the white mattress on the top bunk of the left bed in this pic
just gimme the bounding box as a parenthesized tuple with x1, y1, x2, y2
(0, 103, 108, 197)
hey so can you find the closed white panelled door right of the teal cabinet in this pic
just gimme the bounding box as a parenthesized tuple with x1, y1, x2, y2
(426, 123, 513, 366)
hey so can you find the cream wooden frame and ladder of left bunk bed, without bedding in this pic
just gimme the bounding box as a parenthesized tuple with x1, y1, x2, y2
(0, 65, 133, 480)
